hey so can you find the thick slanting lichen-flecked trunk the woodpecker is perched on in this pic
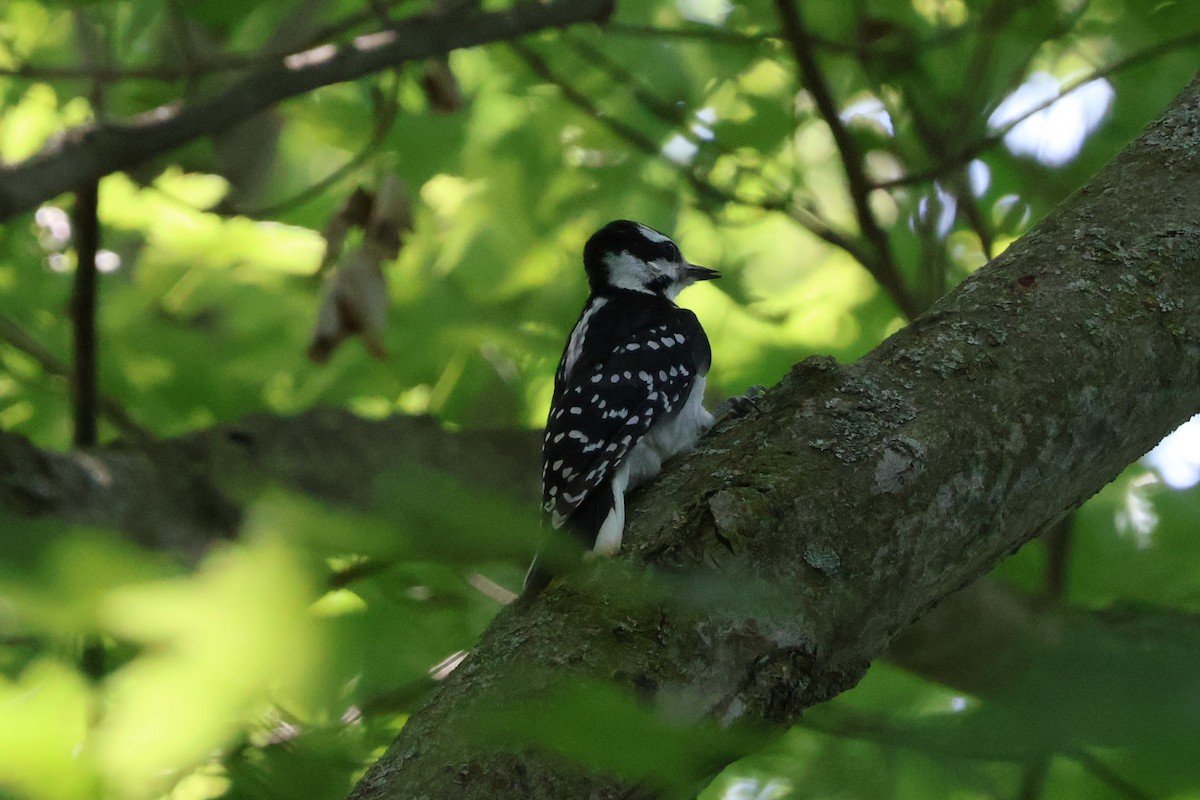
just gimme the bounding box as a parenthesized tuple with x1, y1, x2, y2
(338, 71, 1200, 799)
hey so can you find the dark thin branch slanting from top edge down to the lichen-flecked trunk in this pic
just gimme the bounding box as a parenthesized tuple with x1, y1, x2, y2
(775, 0, 920, 319)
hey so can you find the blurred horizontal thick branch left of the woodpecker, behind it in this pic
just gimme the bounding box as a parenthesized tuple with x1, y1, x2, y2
(0, 409, 541, 555)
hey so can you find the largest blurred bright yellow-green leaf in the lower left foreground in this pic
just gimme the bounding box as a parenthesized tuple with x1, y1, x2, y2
(96, 536, 322, 796)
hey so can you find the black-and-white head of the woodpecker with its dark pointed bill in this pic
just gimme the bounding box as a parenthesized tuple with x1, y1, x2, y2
(583, 219, 721, 300)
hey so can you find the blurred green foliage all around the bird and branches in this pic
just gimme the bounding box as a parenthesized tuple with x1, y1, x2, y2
(0, 0, 1200, 800)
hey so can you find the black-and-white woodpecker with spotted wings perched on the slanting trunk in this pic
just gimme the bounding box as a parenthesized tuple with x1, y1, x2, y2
(526, 219, 720, 591)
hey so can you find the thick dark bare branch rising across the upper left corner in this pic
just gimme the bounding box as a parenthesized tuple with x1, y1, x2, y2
(0, 0, 613, 221)
